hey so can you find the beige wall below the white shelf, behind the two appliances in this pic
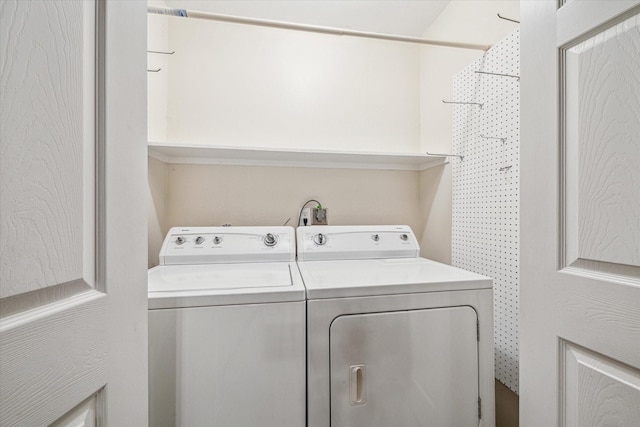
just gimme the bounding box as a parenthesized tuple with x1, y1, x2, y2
(149, 159, 422, 267)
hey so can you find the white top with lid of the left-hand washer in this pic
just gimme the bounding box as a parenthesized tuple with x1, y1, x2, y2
(148, 262, 305, 309)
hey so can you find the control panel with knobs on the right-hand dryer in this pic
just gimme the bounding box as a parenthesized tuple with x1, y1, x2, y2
(297, 225, 420, 261)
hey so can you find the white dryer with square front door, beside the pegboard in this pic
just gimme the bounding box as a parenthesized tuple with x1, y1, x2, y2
(297, 226, 495, 427)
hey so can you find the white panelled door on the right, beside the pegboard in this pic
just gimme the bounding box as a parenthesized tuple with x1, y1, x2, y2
(520, 0, 640, 427)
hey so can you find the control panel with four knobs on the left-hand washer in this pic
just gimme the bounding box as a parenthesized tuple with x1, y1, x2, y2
(160, 227, 296, 265)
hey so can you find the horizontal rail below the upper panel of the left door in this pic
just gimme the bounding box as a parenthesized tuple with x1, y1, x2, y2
(0, 290, 107, 425)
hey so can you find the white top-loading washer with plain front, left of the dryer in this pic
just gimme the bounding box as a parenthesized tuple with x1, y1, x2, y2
(149, 227, 306, 427)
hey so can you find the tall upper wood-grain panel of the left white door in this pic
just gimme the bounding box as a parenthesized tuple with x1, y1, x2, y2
(0, 1, 95, 298)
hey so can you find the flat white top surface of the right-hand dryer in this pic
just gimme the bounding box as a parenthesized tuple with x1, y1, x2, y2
(298, 258, 493, 299)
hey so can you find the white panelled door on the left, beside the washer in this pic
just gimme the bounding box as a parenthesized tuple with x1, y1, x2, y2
(0, 0, 147, 426)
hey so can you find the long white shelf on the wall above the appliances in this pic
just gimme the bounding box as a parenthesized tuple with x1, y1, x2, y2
(149, 142, 446, 170)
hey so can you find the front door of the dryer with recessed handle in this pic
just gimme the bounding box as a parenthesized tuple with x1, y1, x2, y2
(330, 306, 479, 427)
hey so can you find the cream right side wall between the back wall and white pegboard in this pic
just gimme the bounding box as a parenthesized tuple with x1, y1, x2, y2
(420, 0, 520, 263)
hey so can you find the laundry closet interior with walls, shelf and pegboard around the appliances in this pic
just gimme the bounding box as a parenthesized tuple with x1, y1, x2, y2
(147, 0, 520, 425)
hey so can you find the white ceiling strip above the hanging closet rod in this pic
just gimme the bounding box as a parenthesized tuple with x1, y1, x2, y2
(166, 0, 449, 37)
